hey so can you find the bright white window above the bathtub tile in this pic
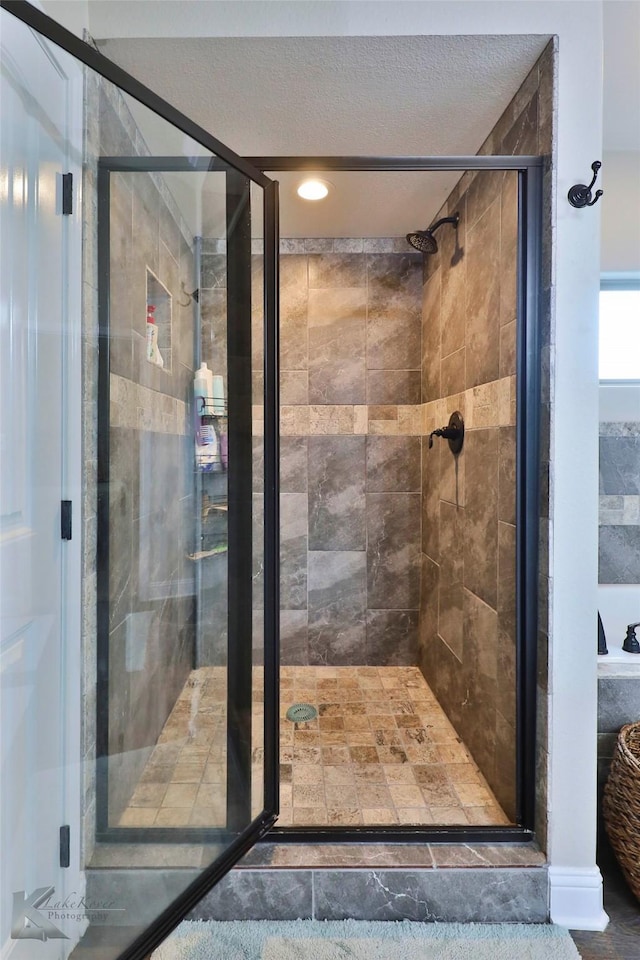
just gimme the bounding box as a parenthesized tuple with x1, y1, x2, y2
(599, 278, 640, 381)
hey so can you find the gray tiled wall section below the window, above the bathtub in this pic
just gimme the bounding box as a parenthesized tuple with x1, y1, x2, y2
(598, 421, 640, 583)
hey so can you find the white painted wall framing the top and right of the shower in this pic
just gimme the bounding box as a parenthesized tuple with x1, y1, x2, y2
(45, 0, 606, 928)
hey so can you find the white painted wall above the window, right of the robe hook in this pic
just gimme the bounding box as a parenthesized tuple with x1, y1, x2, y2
(599, 150, 640, 273)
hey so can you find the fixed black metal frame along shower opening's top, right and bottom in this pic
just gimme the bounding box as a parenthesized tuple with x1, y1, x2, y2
(248, 155, 543, 843)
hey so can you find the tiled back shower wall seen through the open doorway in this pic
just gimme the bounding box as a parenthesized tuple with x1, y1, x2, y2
(280, 244, 422, 666)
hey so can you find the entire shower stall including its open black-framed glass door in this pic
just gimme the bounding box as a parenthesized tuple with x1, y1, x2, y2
(2, 4, 542, 960)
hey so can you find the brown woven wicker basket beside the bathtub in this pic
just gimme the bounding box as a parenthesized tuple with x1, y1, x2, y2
(602, 722, 640, 900)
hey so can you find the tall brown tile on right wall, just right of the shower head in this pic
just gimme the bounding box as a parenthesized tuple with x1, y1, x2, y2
(465, 201, 500, 387)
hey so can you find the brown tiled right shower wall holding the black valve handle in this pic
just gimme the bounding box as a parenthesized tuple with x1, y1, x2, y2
(419, 48, 551, 817)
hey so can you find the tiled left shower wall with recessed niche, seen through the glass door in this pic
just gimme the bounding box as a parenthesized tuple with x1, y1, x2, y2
(83, 74, 195, 832)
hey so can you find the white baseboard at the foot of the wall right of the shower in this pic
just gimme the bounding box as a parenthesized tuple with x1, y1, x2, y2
(549, 866, 609, 930)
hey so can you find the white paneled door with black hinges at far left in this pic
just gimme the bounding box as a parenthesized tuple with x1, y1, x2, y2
(0, 11, 73, 960)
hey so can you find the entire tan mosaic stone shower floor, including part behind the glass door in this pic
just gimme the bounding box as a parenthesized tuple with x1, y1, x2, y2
(119, 667, 509, 827)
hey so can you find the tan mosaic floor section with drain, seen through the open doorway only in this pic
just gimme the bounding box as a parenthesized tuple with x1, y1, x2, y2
(279, 667, 509, 826)
